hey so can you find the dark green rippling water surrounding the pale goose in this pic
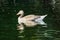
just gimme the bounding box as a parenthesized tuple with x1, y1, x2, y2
(0, 0, 60, 40)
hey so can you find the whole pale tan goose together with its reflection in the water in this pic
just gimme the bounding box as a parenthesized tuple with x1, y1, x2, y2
(17, 10, 47, 30)
